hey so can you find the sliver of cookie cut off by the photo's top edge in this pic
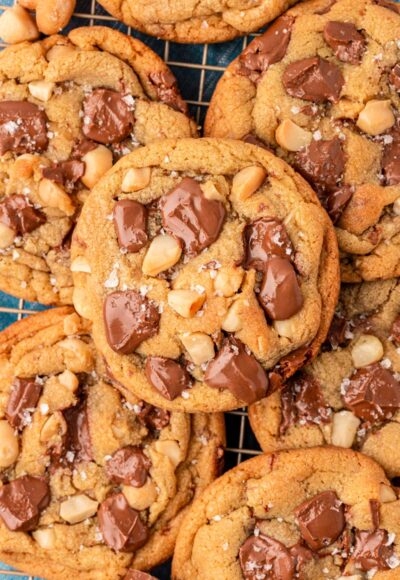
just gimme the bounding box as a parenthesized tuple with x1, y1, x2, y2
(95, 0, 296, 43)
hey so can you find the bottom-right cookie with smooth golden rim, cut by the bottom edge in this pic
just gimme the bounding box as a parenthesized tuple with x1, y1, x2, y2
(172, 447, 400, 580)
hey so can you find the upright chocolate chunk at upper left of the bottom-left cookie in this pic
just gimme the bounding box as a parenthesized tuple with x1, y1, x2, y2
(6, 377, 42, 429)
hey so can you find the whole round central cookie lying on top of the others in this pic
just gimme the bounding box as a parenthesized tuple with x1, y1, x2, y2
(72, 139, 339, 412)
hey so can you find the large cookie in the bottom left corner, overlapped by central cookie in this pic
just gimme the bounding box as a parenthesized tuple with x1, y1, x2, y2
(0, 307, 224, 580)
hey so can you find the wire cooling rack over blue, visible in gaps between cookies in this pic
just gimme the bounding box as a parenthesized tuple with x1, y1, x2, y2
(0, 0, 260, 580)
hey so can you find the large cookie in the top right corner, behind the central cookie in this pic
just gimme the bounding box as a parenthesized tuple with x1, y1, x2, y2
(206, 0, 400, 283)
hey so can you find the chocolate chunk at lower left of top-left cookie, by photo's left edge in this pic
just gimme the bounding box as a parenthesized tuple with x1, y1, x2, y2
(0, 194, 46, 236)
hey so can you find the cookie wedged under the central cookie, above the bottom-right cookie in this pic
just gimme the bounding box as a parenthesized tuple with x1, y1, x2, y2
(249, 279, 400, 477)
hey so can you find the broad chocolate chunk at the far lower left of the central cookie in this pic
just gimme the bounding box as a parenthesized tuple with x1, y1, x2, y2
(103, 290, 160, 354)
